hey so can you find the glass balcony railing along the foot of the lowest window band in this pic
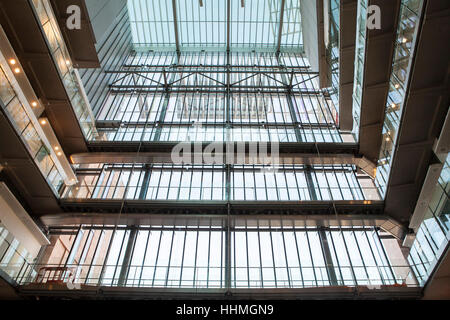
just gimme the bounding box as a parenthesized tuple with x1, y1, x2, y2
(18, 264, 418, 289)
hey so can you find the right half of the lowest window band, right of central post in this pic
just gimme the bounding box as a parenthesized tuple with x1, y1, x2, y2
(231, 224, 403, 288)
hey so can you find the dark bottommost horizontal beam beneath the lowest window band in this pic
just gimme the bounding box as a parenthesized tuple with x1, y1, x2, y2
(18, 283, 422, 303)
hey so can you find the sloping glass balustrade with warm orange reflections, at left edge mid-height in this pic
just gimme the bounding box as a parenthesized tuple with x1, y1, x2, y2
(0, 66, 64, 194)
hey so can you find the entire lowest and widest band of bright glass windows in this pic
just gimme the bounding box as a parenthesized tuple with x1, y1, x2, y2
(26, 218, 415, 288)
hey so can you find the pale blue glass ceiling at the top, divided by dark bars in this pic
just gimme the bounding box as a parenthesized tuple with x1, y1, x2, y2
(128, 0, 303, 52)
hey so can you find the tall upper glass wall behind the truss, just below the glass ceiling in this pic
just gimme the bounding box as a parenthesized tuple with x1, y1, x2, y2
(93, 52, 342, 142)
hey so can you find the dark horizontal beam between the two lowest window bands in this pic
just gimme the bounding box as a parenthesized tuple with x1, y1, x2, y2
(56, 199, 384, 219)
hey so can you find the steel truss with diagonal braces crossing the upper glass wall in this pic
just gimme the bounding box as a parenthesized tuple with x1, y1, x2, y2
(105, 64, 323, 95)
